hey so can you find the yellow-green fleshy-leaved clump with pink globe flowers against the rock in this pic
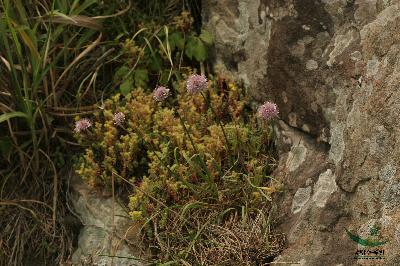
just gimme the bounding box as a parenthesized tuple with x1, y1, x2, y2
(77, 75, 279, 264)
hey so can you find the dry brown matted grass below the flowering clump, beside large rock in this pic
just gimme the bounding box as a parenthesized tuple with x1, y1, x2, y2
(195, 212, 284, 265)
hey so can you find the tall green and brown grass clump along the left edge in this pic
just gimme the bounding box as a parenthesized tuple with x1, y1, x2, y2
(0, 0, 111, 265)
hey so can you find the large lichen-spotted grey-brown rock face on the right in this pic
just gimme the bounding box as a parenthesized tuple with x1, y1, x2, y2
(203, 0, 400, 265)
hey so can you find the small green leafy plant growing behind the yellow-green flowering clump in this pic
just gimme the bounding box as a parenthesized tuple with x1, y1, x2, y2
(114, 11, 213, 95)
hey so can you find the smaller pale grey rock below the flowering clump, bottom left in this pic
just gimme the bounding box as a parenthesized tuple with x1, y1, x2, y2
(71, 177, 143, 266)
